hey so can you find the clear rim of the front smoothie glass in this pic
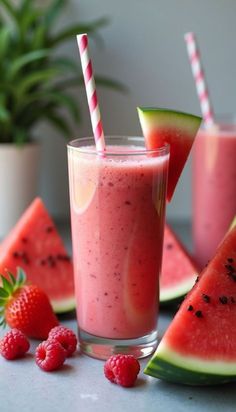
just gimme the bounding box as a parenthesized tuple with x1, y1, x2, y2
(67, 135, 170, 157)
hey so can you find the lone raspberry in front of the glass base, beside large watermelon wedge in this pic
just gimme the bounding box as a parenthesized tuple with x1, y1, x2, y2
(104, 355, 140, 387)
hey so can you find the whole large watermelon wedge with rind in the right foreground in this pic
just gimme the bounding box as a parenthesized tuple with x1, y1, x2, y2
(145, 222, 236, 385)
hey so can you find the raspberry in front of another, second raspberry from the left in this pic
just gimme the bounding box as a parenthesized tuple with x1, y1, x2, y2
(35, 340, 66, 372)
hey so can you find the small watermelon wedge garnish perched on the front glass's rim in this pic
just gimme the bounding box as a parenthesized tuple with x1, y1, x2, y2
(138, 107, 202, 202)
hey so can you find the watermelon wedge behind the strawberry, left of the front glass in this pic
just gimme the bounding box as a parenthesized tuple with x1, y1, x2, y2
(0, 198, 75, 313)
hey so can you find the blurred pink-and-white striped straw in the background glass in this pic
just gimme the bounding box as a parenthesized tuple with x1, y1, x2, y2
(184, 32, 214, 126)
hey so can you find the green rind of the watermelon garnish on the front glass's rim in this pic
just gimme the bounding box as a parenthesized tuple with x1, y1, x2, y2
(137, 107, 202, 135)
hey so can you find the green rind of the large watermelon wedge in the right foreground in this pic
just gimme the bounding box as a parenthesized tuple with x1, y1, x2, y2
(144, 342, 236, 385)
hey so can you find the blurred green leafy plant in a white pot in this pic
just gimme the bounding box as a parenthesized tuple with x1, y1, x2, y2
(0, 0, 120, 238)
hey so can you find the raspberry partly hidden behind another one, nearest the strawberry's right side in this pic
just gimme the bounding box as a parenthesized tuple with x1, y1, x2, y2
(48, 326, 77, 357)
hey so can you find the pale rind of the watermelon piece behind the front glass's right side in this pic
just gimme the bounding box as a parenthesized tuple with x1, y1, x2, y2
(160, 273, 197, 304)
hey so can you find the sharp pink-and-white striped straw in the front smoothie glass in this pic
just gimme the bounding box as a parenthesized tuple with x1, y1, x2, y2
(77, 33, 106, 152)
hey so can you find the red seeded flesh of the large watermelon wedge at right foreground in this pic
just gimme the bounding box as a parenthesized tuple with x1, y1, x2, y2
(162, 222, 236, 362)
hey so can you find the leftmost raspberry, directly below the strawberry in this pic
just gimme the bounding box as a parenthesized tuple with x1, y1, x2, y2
(0, 329, 30, 360)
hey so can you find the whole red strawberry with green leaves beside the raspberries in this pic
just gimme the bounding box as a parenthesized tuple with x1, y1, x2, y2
(0, 268, 59, 339)
